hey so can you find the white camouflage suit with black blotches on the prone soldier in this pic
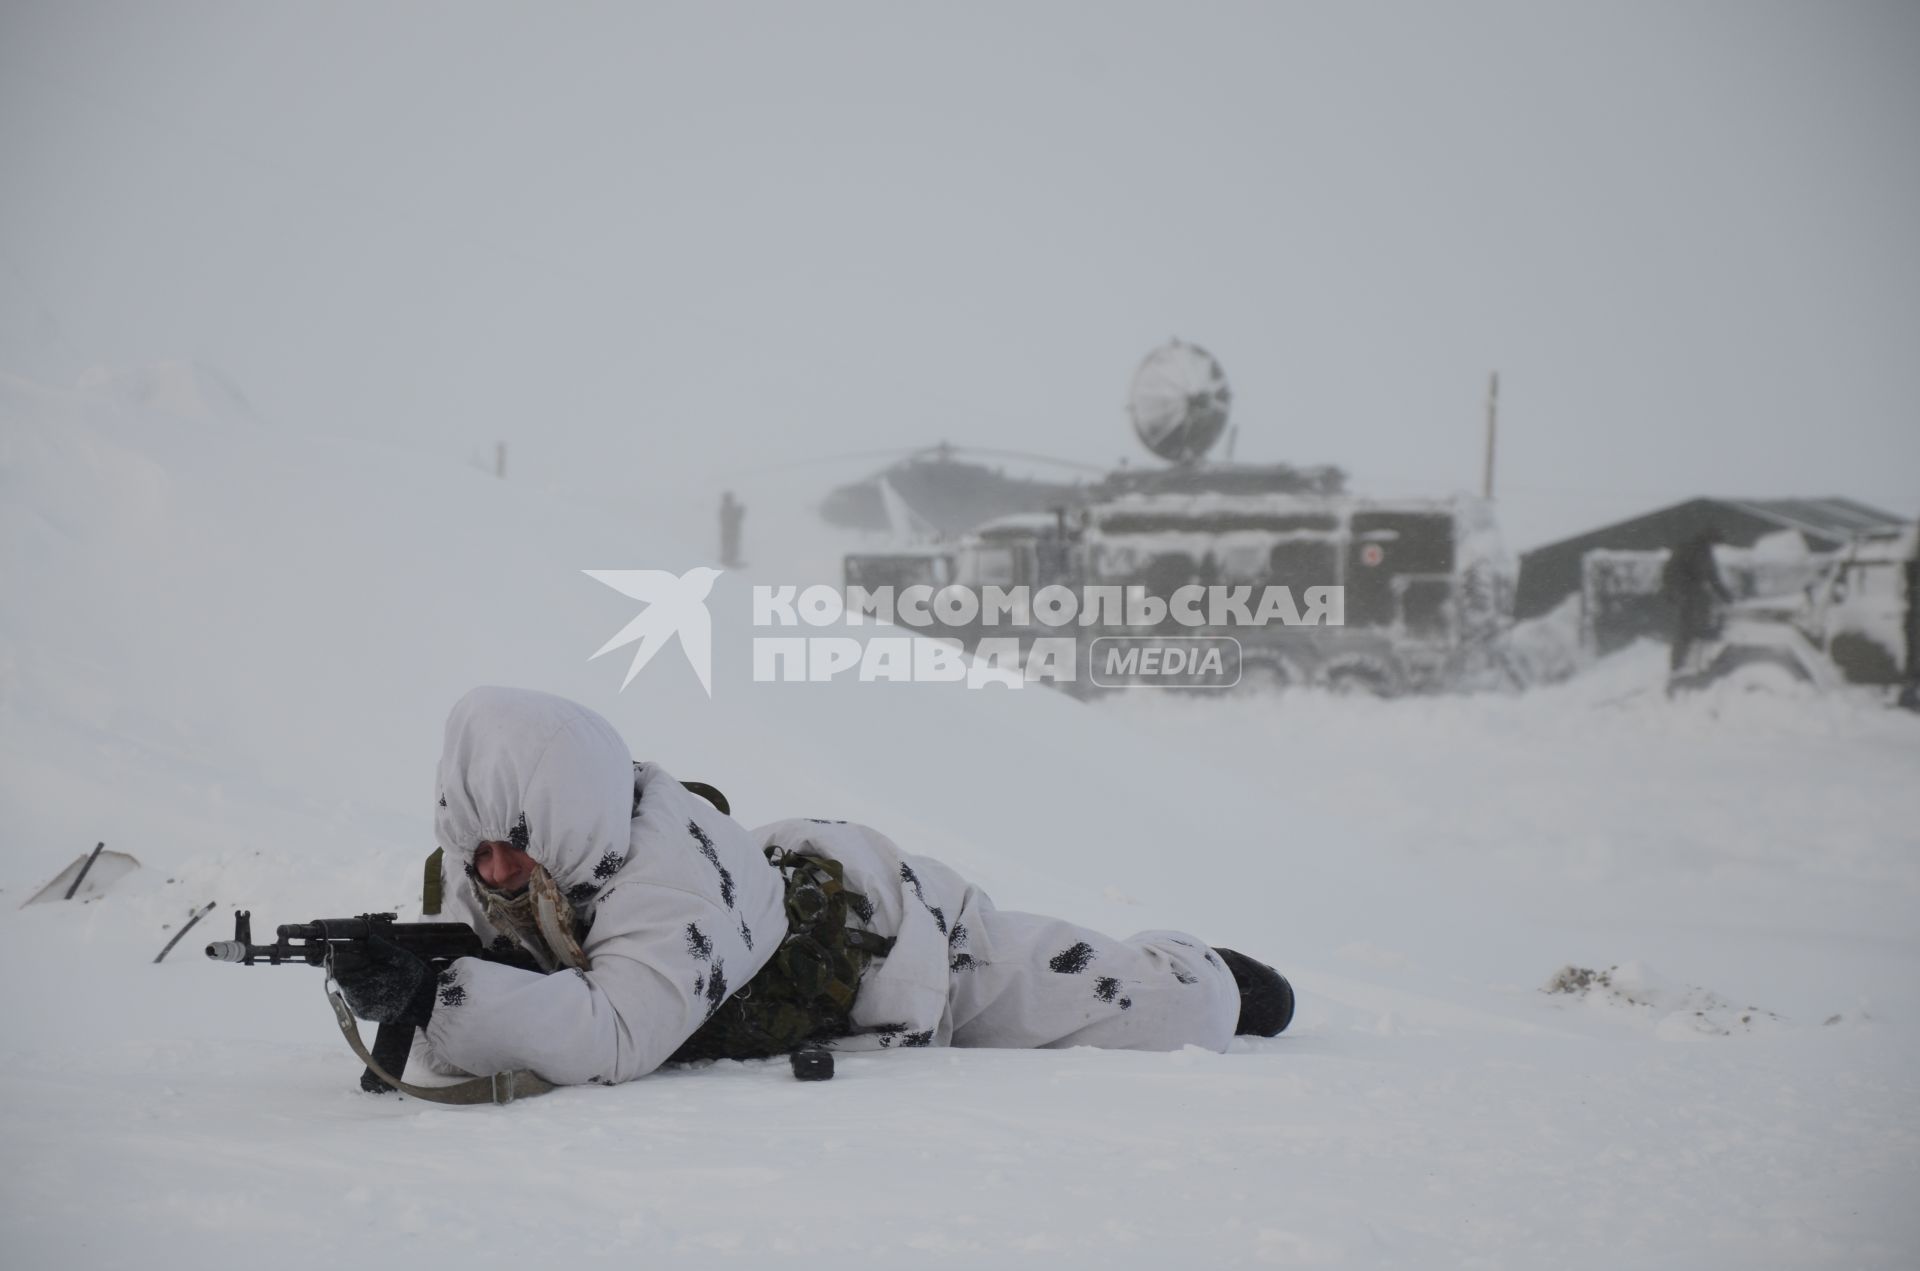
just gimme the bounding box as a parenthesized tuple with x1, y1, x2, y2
(424, 687, 1240, 1085)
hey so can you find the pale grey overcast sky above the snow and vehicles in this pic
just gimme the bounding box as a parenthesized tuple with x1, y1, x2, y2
(0, 0, 1920, 545)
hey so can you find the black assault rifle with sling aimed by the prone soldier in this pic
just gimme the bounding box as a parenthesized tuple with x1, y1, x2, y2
(207, 910, 547, 1102)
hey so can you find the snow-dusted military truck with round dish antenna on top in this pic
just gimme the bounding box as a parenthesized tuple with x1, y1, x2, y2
(845, 340, 1515, 695)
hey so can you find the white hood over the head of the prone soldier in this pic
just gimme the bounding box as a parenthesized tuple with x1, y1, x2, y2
(434, 687, 634, 910)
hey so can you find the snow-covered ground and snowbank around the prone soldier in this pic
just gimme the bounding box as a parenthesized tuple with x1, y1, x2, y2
(0, 367, 1920, 1269)
